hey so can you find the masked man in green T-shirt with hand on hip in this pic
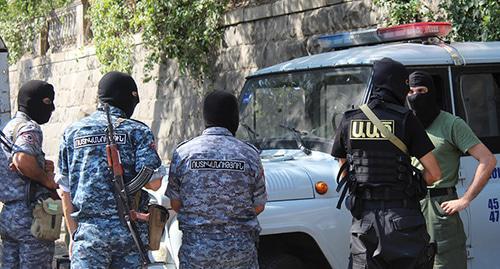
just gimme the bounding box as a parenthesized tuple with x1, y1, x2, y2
(407, 71, 496, 269)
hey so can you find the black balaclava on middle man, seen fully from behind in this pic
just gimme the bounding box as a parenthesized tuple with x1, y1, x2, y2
(203, 90, 240, 135)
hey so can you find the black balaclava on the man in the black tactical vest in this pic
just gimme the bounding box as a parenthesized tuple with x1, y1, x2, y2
(371, 58, 410, 106)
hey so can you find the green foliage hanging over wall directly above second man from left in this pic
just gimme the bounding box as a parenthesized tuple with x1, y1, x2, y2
(89, 0, 228, 80)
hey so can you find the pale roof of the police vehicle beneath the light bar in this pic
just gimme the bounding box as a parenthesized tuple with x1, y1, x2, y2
(249, 41, 500, 77)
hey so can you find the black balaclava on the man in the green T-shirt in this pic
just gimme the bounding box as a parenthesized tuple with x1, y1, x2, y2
(407, 71, 441, 128)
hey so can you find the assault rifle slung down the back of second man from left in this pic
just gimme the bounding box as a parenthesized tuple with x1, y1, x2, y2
(104, 104, 151, 267)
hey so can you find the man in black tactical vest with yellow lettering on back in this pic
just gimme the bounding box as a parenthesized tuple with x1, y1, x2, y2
(332, 58, 440, 268)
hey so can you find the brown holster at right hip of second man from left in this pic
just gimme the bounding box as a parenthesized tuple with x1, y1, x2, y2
(148, 205, 169, 250)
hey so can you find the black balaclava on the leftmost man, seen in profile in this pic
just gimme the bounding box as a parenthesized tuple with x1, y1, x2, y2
(17, 80, 55, 124)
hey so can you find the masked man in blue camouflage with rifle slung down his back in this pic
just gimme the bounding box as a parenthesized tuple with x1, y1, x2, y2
(57, 72, 166, 268)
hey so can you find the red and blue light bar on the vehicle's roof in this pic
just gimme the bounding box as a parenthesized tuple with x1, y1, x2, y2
(318, 22, 451, 49)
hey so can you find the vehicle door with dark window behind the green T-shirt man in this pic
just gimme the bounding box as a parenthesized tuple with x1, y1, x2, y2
(452, 65, 500, 269)
